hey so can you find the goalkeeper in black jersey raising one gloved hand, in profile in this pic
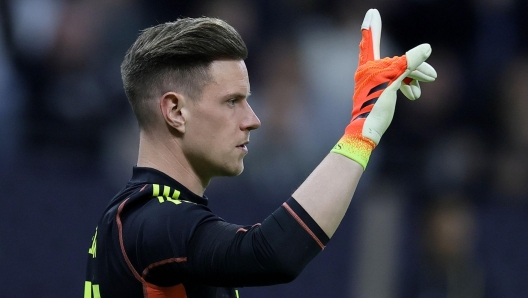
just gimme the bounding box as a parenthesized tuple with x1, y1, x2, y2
(85, 10, 436, 298)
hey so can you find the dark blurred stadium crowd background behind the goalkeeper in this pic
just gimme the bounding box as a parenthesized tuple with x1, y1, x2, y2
(0, 0, 528, 298)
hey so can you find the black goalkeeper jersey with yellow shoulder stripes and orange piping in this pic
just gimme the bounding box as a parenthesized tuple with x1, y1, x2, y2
(84, 167, 329, 298)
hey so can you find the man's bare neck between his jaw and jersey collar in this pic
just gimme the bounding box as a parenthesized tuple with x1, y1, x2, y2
(137, 131, 209, 196)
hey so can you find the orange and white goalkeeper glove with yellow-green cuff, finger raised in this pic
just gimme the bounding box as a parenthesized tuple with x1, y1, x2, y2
(331, 9, 436, 169)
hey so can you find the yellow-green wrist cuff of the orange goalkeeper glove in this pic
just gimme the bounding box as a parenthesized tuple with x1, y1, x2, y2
(330, 134, 376, 170)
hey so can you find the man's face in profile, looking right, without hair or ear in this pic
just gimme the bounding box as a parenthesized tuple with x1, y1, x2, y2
(182, 60, 260, 179)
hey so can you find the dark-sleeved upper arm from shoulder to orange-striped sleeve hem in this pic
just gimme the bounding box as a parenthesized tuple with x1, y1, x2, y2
(127, 198, 328, 287)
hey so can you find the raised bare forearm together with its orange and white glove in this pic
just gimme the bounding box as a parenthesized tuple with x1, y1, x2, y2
(293, 9, 436, 237)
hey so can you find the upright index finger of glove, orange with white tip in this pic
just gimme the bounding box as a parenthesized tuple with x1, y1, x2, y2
(359, 8, 381, 65)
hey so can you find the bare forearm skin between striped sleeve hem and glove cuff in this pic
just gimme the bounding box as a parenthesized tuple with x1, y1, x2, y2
(292, 152, 363, 237)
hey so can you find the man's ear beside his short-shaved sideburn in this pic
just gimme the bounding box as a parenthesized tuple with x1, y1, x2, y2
(160, 92, 185, 133)
